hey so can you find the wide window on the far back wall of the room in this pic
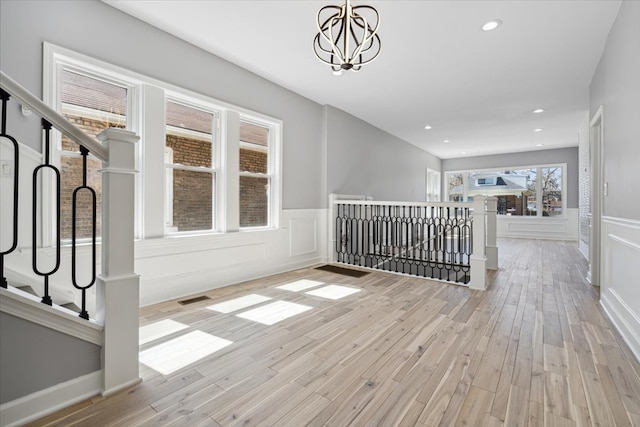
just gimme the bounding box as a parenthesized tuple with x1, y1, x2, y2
(446, 165, 565, 217)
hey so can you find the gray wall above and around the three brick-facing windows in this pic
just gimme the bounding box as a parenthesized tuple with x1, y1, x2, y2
(0, 0, 326, 209)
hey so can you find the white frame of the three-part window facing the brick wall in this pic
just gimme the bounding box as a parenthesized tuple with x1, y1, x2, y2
(42, 42, 283, 245)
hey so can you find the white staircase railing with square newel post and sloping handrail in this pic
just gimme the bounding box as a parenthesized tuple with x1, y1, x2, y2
(0, 71, 140, 402)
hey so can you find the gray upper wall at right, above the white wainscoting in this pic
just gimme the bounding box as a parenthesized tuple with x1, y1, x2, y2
(589, 1, 640, 220)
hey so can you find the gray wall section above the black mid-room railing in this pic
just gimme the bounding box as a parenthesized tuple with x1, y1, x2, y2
(325, 106, 440, 201)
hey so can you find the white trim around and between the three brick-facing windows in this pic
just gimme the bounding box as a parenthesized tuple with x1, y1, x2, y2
(42, 42, 283, 244)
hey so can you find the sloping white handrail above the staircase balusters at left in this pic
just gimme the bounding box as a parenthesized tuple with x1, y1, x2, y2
(0, 71, 109, 161)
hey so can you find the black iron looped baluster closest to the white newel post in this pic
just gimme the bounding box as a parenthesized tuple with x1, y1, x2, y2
(71, 145, 97, 320)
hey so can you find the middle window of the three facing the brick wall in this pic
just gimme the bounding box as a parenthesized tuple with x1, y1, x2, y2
(164, 101, 217, 232)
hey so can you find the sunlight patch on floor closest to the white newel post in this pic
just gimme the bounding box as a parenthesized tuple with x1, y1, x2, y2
(140, 331, 233, 375)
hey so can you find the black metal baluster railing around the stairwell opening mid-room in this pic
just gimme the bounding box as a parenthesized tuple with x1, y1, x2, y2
(335, 201, 473, 284)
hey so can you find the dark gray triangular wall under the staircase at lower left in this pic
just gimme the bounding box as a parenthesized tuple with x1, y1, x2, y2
(0, 313, 101, 404)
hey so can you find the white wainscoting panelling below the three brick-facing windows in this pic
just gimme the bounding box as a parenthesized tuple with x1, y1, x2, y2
(135, 209, 327, 306)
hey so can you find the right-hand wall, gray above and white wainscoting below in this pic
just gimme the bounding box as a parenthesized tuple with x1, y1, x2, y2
(589, 1, 640, 360)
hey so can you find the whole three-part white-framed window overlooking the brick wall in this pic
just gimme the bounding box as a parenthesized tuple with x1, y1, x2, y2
(43, 43, 283, 242)
